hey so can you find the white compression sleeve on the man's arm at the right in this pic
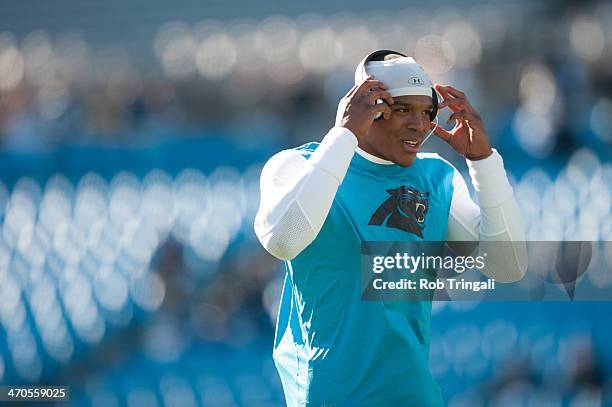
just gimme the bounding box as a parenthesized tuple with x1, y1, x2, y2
(448, 150, 527, 282)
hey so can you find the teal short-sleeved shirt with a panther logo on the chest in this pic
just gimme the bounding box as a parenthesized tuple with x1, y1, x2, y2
(273, 143, 454, 407)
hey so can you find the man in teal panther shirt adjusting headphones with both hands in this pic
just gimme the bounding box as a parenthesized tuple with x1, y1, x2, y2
(255, 51, 525, 407)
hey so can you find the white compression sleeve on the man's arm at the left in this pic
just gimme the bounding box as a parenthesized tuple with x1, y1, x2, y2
(255, 127, 357, 260)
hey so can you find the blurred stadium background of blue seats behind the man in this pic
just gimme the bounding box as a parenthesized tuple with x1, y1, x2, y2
(0, 0, 612, 407)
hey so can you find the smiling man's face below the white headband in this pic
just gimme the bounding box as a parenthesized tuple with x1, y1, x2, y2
(359, 96, 433, 167)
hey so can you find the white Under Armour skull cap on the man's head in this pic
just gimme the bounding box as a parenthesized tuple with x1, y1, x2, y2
(355, 57, 432, 97)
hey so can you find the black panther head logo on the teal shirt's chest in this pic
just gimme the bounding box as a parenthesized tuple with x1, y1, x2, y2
(368, 185, 429, 238)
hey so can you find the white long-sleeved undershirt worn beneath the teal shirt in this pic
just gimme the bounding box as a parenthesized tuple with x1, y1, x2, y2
(255, 127, 527, 282)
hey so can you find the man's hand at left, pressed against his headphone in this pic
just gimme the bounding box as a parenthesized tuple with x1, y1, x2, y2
(336, 76, 393, 140)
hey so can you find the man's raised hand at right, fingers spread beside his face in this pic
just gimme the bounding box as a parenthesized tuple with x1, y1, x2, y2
(431, 84, 493, 161)
